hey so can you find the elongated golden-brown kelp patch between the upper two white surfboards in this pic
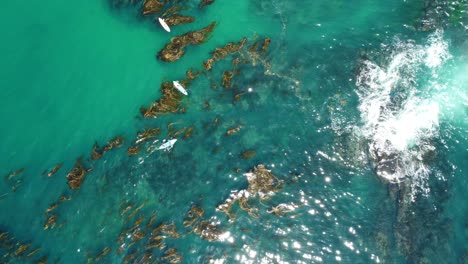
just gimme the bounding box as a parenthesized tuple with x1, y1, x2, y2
(158, 22, 216, 62)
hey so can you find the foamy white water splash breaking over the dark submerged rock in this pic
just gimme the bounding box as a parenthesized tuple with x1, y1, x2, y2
(356, 31, 450, 199)
